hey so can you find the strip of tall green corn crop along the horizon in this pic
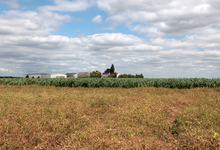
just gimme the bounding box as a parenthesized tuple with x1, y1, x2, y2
(0, 78, 220, 89)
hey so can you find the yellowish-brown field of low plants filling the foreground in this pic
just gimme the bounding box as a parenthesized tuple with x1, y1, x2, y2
(0, 85, 220, 150)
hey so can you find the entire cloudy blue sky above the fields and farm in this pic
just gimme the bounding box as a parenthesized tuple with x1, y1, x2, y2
(0, 0, 220, 78)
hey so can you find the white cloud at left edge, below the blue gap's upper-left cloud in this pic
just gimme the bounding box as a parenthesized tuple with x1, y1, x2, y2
(0, 10, 71, 36)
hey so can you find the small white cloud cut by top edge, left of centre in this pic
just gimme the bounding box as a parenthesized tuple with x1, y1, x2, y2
(38, 0, 94, 12)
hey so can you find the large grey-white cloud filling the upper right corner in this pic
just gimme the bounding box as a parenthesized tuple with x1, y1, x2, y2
(97, 0, 220, 37)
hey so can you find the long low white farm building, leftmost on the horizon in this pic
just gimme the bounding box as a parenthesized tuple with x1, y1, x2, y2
(23, 73, 66, 78)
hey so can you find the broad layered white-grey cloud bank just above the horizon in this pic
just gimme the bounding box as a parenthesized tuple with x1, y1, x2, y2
(0, 33, 220, 78)
